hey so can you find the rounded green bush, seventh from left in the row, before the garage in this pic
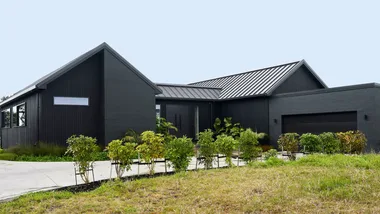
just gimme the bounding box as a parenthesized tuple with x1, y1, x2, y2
(239, 129, 262, 162)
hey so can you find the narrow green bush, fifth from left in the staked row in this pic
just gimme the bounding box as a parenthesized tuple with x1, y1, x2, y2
(198, 129, 217, 169)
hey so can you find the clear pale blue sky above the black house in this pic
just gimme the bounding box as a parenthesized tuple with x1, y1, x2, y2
(0, 0, 380, 96)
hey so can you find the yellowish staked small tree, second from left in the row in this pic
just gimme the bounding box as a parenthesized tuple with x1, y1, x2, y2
(107, 140, 136, 178)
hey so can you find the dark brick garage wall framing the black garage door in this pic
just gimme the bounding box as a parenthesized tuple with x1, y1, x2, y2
(269, 87, 380, 151)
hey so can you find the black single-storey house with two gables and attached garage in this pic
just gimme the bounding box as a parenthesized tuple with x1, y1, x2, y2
(0, 43, 380, 150)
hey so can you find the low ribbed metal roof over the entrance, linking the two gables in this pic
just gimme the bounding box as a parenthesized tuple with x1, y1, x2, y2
(156, 83, 221, 100)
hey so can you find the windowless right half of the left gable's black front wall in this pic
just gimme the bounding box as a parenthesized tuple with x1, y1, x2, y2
(104, 50, 156, 144)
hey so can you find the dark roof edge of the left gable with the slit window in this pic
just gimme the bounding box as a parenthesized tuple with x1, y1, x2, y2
(0, 42, 162, 106)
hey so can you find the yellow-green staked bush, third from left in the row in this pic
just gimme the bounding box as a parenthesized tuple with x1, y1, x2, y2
(136, 131, 164, 175)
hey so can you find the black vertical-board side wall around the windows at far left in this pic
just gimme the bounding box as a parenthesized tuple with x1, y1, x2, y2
(1, 92, 38, 148)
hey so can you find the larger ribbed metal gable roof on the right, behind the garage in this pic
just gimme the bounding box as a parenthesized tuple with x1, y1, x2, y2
(189, 60, 327, 100)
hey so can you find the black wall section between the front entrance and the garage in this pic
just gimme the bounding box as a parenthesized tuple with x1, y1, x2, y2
(220, 97, 269, 133)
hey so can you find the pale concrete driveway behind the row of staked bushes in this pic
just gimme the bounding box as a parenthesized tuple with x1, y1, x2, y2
(0, 158, 242, 201)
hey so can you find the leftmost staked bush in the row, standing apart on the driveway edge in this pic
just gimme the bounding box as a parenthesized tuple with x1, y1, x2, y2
(66, 135, 99, 183)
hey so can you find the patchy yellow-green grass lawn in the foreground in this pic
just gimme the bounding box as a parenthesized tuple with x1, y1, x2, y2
(0, 155, 380, 213)
